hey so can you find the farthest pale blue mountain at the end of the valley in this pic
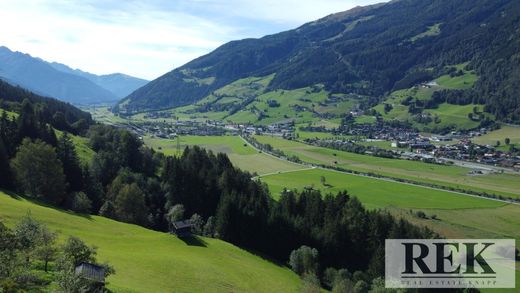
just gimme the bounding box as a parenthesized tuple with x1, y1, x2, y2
(50, 62, 148, 99)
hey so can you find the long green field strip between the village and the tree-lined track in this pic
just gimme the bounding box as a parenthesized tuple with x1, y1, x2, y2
(255, 136, 520, 198)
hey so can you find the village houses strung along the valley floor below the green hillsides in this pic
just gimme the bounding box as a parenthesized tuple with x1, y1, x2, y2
(120, 115, 520, 174)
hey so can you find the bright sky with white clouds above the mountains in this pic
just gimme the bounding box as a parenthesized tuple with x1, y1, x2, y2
(0, 0, 382, 80)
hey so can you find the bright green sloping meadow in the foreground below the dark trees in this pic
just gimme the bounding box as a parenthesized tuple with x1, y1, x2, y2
(0, 192, 300, 292)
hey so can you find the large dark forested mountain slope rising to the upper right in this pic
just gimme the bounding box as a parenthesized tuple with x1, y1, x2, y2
(115, 0, 520, 122)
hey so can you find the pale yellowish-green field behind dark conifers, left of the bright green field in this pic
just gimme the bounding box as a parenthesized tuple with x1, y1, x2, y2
(144, 136, 303, 174)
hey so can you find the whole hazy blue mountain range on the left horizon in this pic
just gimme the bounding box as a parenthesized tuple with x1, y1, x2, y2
(0, 46, 147, 104)
